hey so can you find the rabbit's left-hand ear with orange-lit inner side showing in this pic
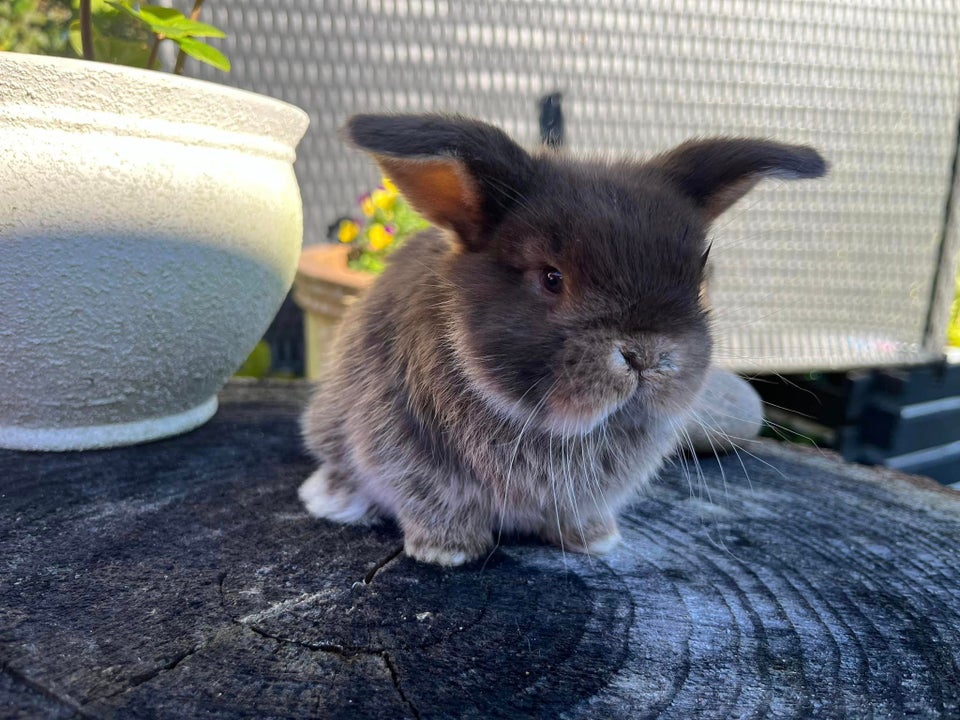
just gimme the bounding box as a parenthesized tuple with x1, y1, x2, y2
(343, 115, 533, 250)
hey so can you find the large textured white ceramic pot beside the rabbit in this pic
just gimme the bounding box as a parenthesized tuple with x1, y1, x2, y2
(0, 53, 308, 450)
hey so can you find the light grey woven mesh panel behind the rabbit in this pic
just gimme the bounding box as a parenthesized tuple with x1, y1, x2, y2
(192, 0, 960, 371)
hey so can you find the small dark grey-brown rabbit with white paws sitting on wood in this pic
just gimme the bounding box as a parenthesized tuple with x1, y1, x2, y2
(299, 114, 826, 566)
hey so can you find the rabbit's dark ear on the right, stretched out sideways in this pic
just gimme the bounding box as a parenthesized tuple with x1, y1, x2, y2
(650, 138, 827, 222)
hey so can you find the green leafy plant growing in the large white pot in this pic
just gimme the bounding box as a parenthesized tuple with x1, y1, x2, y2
(70, 0, 230, 74)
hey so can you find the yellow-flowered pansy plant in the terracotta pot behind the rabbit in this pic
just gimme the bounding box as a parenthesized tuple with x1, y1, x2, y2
(334, 178, 430, 273)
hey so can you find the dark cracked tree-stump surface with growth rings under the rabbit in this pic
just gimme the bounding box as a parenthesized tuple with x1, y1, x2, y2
(0, 383, 960, 718)
